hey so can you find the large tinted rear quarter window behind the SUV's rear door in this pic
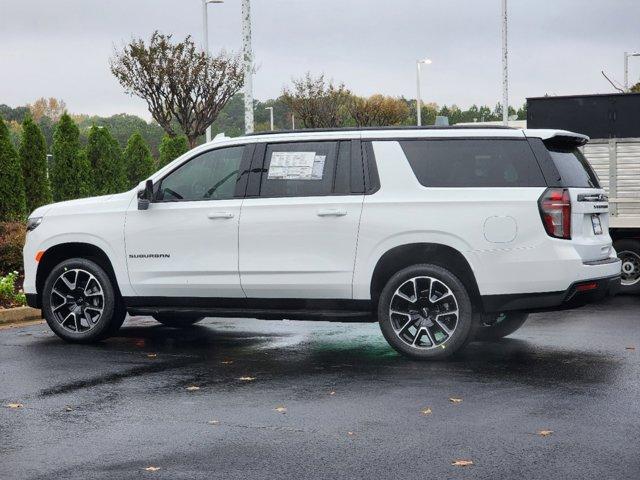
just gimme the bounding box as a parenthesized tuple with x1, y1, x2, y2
(400, 139, 546, 187)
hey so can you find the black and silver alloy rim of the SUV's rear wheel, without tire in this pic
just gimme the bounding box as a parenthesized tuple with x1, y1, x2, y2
(389, 277, 459, 349)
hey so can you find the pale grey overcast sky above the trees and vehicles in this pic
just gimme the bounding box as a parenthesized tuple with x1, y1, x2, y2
(0, 0, 640, 118)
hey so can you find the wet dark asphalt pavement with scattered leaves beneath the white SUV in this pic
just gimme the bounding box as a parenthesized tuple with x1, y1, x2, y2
(0, 297, 640, 480)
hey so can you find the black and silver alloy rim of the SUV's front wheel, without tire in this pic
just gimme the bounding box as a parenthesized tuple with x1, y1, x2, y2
(50, 268, 105, 333)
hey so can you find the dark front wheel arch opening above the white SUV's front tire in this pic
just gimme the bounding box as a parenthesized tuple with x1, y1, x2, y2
(36, 242, 121, 305)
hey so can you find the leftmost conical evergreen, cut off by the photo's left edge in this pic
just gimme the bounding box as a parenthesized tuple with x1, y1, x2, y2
(0, 118, 27, 221)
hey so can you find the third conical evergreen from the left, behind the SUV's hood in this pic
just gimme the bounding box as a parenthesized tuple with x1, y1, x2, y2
(50, 113, 91, 202)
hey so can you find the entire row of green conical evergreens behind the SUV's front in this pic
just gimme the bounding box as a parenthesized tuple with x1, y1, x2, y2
(0, 113, 189, 222)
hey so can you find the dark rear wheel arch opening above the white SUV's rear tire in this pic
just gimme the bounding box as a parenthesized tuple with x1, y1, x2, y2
(370, 243, 482, 307)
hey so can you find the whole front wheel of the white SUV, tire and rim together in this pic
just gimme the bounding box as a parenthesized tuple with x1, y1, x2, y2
(42, 258, 121, 343)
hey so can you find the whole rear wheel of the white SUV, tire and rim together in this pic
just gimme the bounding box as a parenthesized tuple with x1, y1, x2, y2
(378, 264, 476, 360)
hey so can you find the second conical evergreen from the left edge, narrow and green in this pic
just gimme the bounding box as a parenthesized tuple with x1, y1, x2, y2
(19, 116, 52, 212)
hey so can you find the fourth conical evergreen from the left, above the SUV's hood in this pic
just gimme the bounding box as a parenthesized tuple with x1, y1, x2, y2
(87, 125, 127, 195)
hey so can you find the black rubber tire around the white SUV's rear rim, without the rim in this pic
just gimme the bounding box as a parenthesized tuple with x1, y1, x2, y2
(378, 264, 475, 360)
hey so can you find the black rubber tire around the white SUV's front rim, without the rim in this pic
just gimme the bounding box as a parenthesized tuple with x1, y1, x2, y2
(42, 258, 115, 343)
